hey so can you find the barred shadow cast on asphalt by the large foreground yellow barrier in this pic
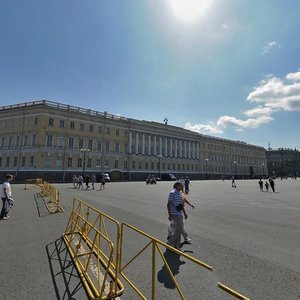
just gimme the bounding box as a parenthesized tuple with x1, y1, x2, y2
(46, 237, 88, 300)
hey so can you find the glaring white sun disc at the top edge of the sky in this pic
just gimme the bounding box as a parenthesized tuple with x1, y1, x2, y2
(170, 0, 212, 22)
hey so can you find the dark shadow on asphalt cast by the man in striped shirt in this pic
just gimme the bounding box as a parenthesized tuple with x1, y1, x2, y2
(157, 250, 185, 289)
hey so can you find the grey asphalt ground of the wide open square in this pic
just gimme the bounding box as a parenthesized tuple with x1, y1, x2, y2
(0, 179, 300, 300)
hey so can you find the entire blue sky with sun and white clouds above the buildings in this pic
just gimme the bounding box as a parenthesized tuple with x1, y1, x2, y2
(0, 0, 300, 149)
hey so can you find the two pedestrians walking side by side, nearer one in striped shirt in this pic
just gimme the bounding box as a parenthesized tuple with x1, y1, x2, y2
(167, 180, 194, 252)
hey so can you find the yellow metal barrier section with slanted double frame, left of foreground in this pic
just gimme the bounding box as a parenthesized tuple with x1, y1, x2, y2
(64, 198, 124, 299)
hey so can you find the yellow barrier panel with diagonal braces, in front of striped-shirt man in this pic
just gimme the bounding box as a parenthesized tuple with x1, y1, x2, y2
(119, 223, 212, 300)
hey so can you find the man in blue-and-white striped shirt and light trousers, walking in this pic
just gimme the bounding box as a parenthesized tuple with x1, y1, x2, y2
(167, 182, 184, 250)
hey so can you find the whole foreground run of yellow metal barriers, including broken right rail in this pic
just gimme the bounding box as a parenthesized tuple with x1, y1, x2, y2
(63, 198, 250, 300)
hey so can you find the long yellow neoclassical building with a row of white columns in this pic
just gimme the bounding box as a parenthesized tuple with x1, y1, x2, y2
(0, 100, 267, 181)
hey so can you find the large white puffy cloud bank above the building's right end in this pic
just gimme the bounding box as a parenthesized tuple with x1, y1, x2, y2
(185, 70, 300, 134)
